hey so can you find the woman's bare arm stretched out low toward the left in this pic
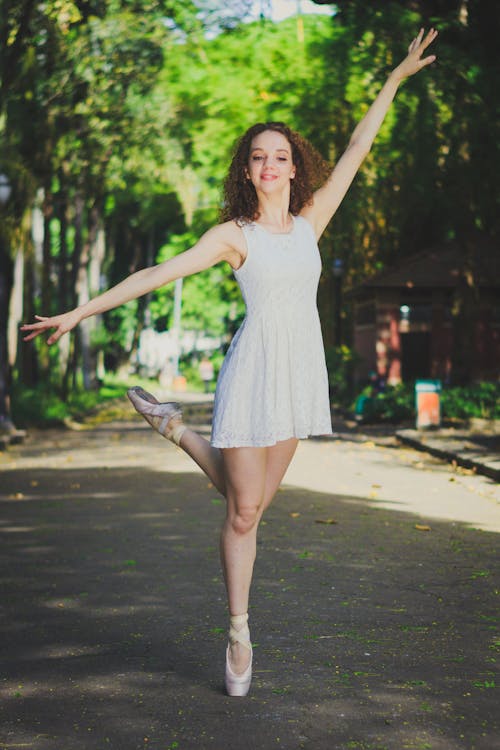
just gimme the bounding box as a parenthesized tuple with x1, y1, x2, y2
(21, 222, 241, 344)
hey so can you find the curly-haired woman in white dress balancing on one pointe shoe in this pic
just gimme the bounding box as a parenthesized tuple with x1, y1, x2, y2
(23, 29, 437, 696)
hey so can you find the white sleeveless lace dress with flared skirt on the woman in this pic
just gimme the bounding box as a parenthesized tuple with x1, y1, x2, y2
(211, 216, 332, 448)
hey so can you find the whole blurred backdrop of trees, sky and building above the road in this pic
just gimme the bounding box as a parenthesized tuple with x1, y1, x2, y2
(0, 0, 500, 431)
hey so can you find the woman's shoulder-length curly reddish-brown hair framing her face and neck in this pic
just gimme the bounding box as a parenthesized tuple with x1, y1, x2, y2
(221, 122, 330, 222)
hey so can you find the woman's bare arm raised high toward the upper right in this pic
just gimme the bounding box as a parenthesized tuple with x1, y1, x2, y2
(301, 29, 438, 237)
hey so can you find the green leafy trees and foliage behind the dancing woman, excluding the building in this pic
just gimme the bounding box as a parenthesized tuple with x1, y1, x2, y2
(0, 0, 500, 424)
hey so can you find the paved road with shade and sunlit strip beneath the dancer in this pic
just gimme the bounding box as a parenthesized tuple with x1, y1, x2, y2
(0, 422, 500, 750)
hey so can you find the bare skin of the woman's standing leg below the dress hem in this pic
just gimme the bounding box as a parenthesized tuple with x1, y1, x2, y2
(221, 438, 298, 672)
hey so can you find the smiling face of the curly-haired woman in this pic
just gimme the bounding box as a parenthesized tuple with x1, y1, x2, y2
(247, 130, 295, 193)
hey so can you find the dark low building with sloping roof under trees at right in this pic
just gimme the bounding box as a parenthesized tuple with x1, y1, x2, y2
(348, 237, 500, 385)
